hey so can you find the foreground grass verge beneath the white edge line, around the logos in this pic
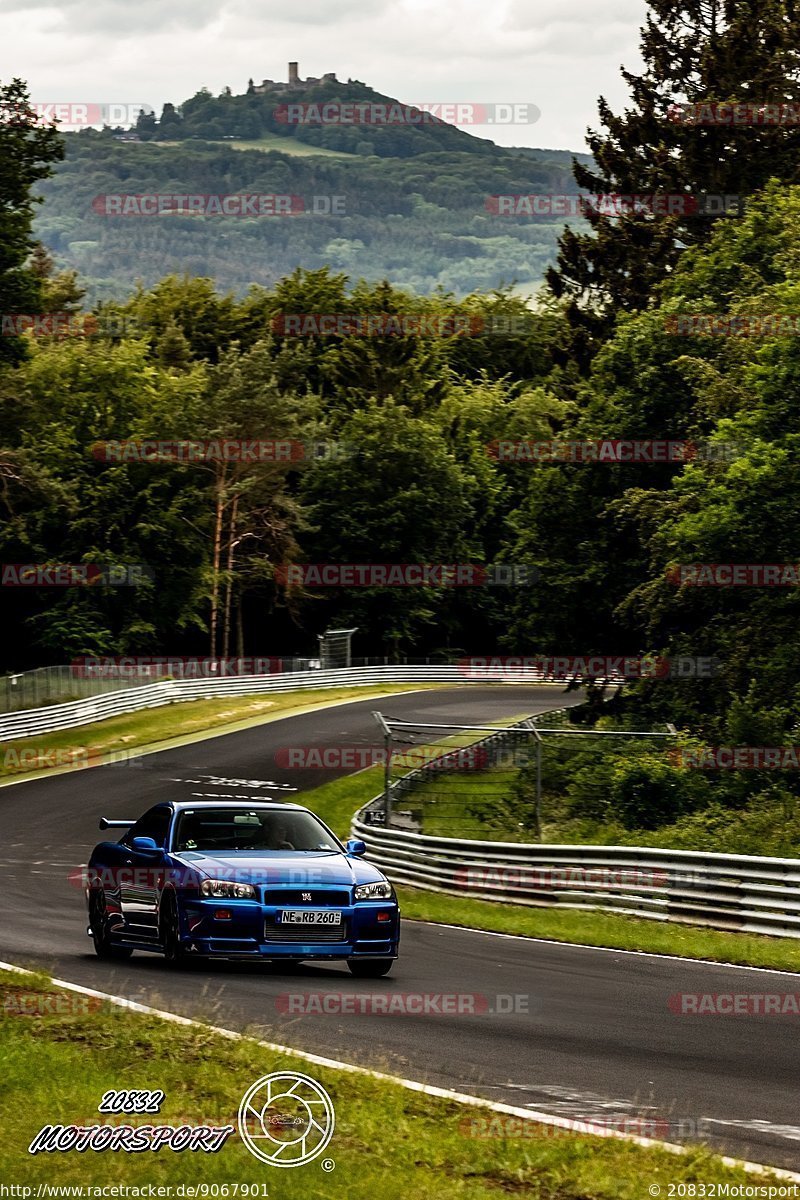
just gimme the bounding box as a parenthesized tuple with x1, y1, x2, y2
(0, 973, 777, 1200)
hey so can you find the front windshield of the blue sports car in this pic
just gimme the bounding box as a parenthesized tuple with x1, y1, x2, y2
(174, 808, 342, 852)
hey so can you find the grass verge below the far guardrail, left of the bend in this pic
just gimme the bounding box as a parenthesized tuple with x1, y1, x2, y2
(0, 683, 447, 779)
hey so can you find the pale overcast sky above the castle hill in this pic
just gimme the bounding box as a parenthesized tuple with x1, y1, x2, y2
(0, 0, 646, 150)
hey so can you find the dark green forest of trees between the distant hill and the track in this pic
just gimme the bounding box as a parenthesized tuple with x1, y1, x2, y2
(0, 0, 800, 836)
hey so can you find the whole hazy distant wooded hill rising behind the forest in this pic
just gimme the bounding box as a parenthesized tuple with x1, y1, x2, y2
(36, 77, 588, 301)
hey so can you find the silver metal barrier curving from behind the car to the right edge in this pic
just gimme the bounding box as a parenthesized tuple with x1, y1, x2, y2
(351, 820, 800, 937)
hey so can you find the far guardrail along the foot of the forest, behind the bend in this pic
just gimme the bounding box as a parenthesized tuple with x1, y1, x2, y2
(0, 664, 582, 742)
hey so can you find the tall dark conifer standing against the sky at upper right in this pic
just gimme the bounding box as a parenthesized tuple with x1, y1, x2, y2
(548, 0, 800, 362)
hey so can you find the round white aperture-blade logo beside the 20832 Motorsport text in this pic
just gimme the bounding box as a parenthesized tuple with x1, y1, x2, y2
(239, 1070, 336, 1166)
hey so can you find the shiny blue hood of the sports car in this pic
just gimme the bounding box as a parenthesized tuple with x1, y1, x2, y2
(172, 850, 385, 888)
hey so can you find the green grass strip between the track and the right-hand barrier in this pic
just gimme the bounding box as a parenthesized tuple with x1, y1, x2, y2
(302, 767, 800, 971)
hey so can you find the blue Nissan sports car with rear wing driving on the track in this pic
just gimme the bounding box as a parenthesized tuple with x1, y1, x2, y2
(85, 800, 399, 978)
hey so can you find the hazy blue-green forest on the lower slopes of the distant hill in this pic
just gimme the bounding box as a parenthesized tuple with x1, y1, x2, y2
(35, 127, 592, 302)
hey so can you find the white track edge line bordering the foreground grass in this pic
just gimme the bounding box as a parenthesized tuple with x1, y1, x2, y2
(0, 960, 800, 1182)
